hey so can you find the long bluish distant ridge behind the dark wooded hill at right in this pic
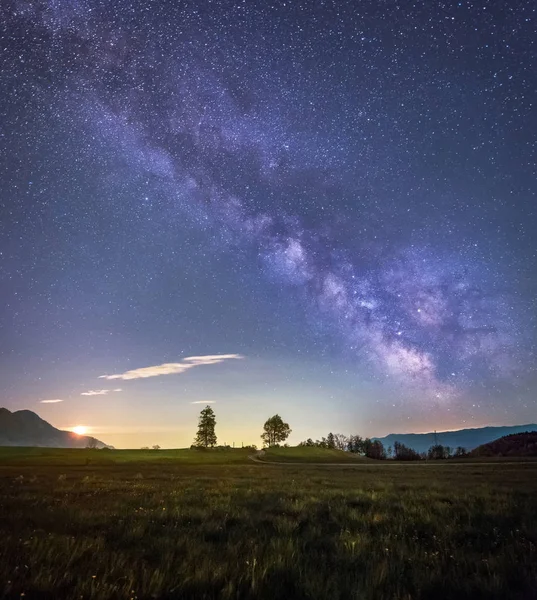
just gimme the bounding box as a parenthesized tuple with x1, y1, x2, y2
(373, 423, 537, 452)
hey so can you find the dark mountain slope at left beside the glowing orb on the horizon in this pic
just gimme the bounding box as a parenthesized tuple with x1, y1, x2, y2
(0, 408, 107, 448)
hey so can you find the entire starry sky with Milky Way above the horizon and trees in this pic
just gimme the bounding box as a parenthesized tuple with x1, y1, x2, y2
(0, 0, 537, 447)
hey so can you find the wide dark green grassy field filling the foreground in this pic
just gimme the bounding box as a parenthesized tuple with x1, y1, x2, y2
(0, 449, 537, 600)
